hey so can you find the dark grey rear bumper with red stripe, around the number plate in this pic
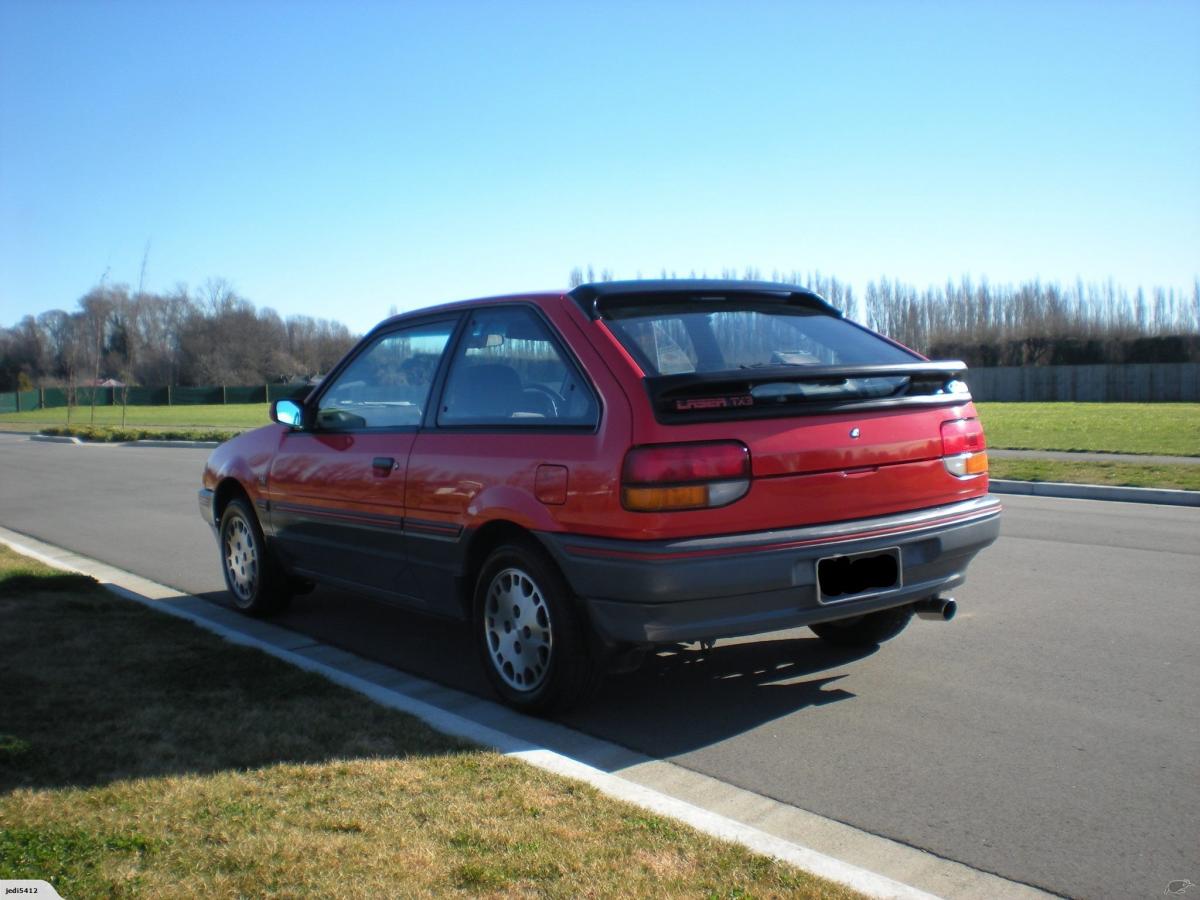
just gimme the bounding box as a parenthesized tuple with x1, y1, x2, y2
(539, 497, 1001, 643)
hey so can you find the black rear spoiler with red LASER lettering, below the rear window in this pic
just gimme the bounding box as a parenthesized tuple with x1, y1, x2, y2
(646, 360, 971, 424)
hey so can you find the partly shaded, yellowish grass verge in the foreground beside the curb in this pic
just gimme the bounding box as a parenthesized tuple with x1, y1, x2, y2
(0, 546, 854, 899)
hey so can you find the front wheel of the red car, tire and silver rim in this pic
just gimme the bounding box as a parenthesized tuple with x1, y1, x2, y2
(218, 497, 290, 616)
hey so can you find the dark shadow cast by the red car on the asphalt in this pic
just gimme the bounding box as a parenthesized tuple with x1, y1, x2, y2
(194, 580, 878, 757)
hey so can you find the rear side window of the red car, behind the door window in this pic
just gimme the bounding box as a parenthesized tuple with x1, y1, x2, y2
(438, 307, 599, 426)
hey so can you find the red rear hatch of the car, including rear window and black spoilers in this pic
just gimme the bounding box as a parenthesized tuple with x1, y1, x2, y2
(577, 284, 988, 533)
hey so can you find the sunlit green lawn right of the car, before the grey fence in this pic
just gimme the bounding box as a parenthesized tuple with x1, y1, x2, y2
(976, 403, 1200, 456)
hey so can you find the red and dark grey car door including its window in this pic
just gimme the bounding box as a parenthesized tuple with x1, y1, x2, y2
(268, 318, 457, 602)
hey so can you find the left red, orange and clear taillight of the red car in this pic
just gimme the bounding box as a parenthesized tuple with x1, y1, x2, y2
(620, 440, 750, 512)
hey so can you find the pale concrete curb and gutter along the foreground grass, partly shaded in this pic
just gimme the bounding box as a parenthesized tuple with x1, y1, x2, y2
(0, 527, 1054, 900)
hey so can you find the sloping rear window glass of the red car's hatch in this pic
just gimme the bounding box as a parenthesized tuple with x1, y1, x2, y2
(606, 300, 920, 376)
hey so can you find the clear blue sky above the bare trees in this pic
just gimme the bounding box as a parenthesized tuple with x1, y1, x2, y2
(0, 0, 1200, 330)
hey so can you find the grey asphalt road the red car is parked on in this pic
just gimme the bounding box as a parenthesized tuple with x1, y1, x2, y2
(0, 434, 1200, 898)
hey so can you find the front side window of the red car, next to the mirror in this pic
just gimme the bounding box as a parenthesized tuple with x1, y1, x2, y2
(317, 322, 455, 431)
